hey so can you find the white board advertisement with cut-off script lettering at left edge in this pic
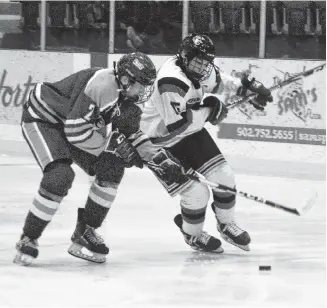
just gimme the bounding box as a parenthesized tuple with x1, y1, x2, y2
(0, 50, 73, 124)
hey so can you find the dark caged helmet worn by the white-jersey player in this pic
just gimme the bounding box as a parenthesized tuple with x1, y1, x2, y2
(178, 33, 215, 81)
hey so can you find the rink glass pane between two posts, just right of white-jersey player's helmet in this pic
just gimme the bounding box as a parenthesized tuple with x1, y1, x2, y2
(188, 1, 260, 58)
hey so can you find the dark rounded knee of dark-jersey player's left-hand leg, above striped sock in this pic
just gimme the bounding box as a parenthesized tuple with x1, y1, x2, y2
(40, 161, 75, 197)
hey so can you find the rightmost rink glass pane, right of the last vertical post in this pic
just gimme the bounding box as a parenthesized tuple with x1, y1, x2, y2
(265, 1, 326, 59)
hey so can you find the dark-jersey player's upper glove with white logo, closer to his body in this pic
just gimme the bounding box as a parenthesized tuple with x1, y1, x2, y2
(104, 130, 143, 169)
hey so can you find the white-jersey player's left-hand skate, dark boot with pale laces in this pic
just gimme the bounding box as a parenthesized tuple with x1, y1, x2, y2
(174, 214, 224, 253)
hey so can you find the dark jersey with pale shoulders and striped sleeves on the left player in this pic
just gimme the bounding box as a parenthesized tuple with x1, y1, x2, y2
(28, 68, 158, 156)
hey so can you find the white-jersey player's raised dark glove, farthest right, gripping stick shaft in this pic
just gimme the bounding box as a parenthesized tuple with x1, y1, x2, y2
(237, 75, 273, 111)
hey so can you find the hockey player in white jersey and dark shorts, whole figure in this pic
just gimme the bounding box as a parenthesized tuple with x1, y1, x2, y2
(141, 34, 272, 253)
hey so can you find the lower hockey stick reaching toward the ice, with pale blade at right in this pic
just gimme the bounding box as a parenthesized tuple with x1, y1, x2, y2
(187, 175, 317, 216)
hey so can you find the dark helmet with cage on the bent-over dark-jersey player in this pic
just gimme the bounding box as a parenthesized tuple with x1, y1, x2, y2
(115, 52, 157, 103)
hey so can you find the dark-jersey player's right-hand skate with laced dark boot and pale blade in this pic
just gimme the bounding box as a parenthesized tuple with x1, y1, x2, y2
(68, 208, 109, 263)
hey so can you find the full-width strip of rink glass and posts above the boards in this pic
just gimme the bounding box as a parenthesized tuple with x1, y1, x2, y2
(0, 1, 326, 59)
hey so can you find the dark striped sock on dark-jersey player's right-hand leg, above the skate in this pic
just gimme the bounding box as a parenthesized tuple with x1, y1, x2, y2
(84, 180, 118, 228)
